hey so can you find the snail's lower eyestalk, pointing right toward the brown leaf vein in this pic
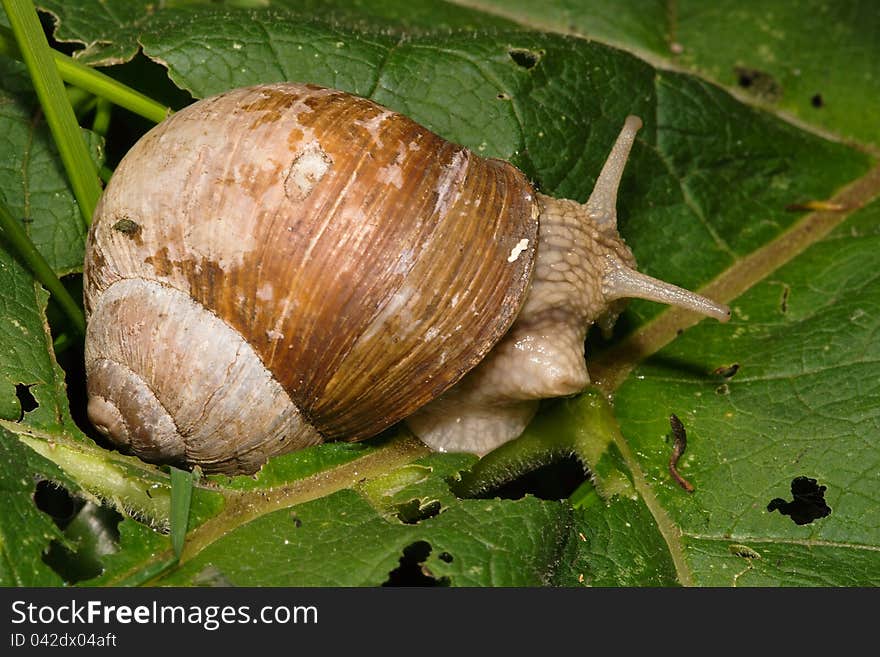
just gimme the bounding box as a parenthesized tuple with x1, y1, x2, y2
(602, 257, 730, 322)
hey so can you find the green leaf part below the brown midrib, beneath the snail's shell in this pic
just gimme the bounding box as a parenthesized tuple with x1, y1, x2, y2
(155, 490, 570, 586)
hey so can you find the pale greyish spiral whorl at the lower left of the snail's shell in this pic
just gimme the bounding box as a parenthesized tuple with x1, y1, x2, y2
(86, 279, 321, 473)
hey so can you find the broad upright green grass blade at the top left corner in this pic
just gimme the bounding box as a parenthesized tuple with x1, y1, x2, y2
(3, 0, 101, 225)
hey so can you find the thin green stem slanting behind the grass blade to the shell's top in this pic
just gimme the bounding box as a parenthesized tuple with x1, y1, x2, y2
(0, 25, 171, 123)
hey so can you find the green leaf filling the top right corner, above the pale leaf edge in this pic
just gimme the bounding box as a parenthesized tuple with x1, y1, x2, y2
(460, 0, 880, 146)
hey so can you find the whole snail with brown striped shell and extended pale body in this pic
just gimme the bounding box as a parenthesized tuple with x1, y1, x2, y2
(84, 83, 729, 474)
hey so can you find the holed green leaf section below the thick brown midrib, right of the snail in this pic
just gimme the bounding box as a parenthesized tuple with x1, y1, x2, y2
(616, 201, 880, 585)
